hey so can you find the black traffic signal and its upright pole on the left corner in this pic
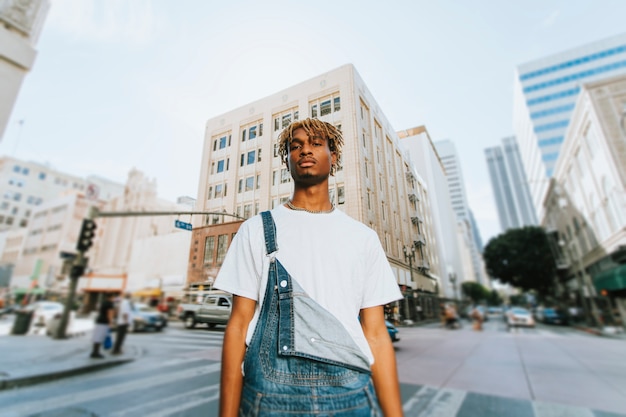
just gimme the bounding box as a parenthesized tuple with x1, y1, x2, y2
(54, 207, 97, 339)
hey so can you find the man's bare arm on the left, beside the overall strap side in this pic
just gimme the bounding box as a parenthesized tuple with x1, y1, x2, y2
(220, 295, 256, 417)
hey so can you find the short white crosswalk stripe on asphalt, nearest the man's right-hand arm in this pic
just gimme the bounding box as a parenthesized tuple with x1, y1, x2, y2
(402, 386, 467, 417)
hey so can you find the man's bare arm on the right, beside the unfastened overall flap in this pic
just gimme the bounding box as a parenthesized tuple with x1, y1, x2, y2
(361, 306, 403, 417)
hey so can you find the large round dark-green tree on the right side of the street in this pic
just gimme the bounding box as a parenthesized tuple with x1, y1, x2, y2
(483, 226, 556, 296)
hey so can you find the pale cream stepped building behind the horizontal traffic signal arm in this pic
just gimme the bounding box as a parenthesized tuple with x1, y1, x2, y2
(84, 169, 192, 309)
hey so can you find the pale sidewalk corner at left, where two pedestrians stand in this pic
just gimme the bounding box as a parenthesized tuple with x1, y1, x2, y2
(0, 318, 141, 390)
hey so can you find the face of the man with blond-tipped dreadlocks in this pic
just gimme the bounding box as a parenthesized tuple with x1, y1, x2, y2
(287, 129, 337, 184)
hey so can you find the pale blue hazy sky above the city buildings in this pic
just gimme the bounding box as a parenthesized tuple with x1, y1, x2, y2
(0, 0, 626, 243)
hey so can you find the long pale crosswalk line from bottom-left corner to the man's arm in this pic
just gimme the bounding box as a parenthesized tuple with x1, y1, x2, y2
(2, 363, 221, 416)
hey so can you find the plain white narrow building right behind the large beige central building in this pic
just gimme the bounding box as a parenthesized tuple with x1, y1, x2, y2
(397, 126, 460, 299)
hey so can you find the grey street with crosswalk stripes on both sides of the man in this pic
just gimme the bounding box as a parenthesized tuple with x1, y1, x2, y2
(0, 317, 626, 417)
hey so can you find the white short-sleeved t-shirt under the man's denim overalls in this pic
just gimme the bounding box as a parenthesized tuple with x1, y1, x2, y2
(214, 205, 402, 363)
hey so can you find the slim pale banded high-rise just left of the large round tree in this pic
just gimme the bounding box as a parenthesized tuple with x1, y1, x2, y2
(435, 140, 482, 286)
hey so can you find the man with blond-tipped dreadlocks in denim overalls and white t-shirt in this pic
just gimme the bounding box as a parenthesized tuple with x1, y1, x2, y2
(214, 119, 402, 417)
